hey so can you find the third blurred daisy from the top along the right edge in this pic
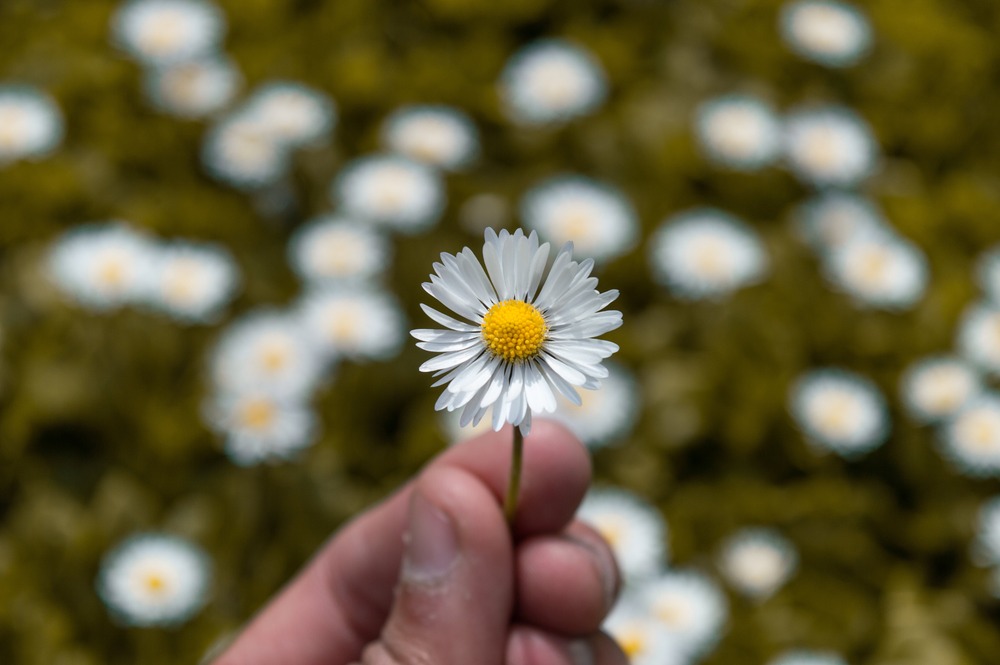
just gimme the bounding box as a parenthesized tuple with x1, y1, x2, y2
(941, 393, 1000, 477)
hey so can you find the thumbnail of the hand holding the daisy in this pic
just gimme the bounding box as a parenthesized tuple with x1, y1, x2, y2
(403, 492, 458, 583)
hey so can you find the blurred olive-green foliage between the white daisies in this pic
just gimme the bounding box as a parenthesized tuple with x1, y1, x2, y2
(0, 0, 1000, 665)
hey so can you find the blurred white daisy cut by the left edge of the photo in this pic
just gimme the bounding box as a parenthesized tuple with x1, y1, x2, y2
(0, 85, 63, 164)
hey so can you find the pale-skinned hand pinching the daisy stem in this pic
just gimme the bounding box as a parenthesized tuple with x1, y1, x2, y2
(216, 421, 628, 665)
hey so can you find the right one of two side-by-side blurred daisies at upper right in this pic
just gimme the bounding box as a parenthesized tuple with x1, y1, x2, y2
(784, 106, 878, 187)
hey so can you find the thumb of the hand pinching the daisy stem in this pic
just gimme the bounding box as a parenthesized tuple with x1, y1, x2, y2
(363, 467, 513, 665)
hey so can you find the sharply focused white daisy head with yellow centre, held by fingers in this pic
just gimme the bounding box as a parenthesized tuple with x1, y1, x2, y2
(411, 229, 622, 435)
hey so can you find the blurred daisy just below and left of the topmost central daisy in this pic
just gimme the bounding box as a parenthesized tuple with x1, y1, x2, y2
(382, 106, 479, 170)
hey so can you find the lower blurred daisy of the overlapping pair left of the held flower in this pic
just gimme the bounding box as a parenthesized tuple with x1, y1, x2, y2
(205, 385, 318, 466)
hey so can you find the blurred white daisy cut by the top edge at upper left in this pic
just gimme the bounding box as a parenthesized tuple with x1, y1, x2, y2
(111, 0, 226, 65)
